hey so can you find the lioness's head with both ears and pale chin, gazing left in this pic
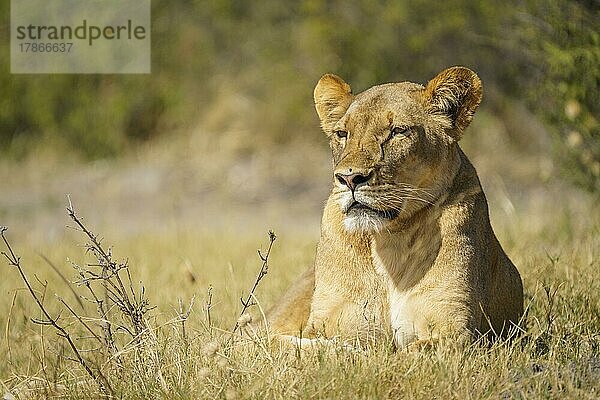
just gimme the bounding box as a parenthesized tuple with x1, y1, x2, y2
(314, 67, 482, 231)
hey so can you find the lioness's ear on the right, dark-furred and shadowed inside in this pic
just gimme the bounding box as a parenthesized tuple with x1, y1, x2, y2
(425, 67, 483, 140)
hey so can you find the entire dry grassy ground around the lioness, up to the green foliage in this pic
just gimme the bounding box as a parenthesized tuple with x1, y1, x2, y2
(0, 117, 600, 399)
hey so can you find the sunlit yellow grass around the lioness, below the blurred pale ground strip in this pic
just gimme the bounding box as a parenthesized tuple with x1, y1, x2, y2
(0, 192, 600, 399)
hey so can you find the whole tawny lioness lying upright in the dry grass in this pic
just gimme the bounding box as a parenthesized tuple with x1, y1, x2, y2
(269, 67, 523, 347)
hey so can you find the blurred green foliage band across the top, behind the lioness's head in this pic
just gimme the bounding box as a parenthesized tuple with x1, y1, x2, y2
(0, 0, 600, 192)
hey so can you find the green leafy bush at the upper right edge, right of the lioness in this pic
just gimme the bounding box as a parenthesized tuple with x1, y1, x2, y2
(516, 1, 600, 191)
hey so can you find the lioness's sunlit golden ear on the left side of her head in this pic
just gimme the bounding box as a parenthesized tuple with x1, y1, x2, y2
(314, 74, 352, 133)
